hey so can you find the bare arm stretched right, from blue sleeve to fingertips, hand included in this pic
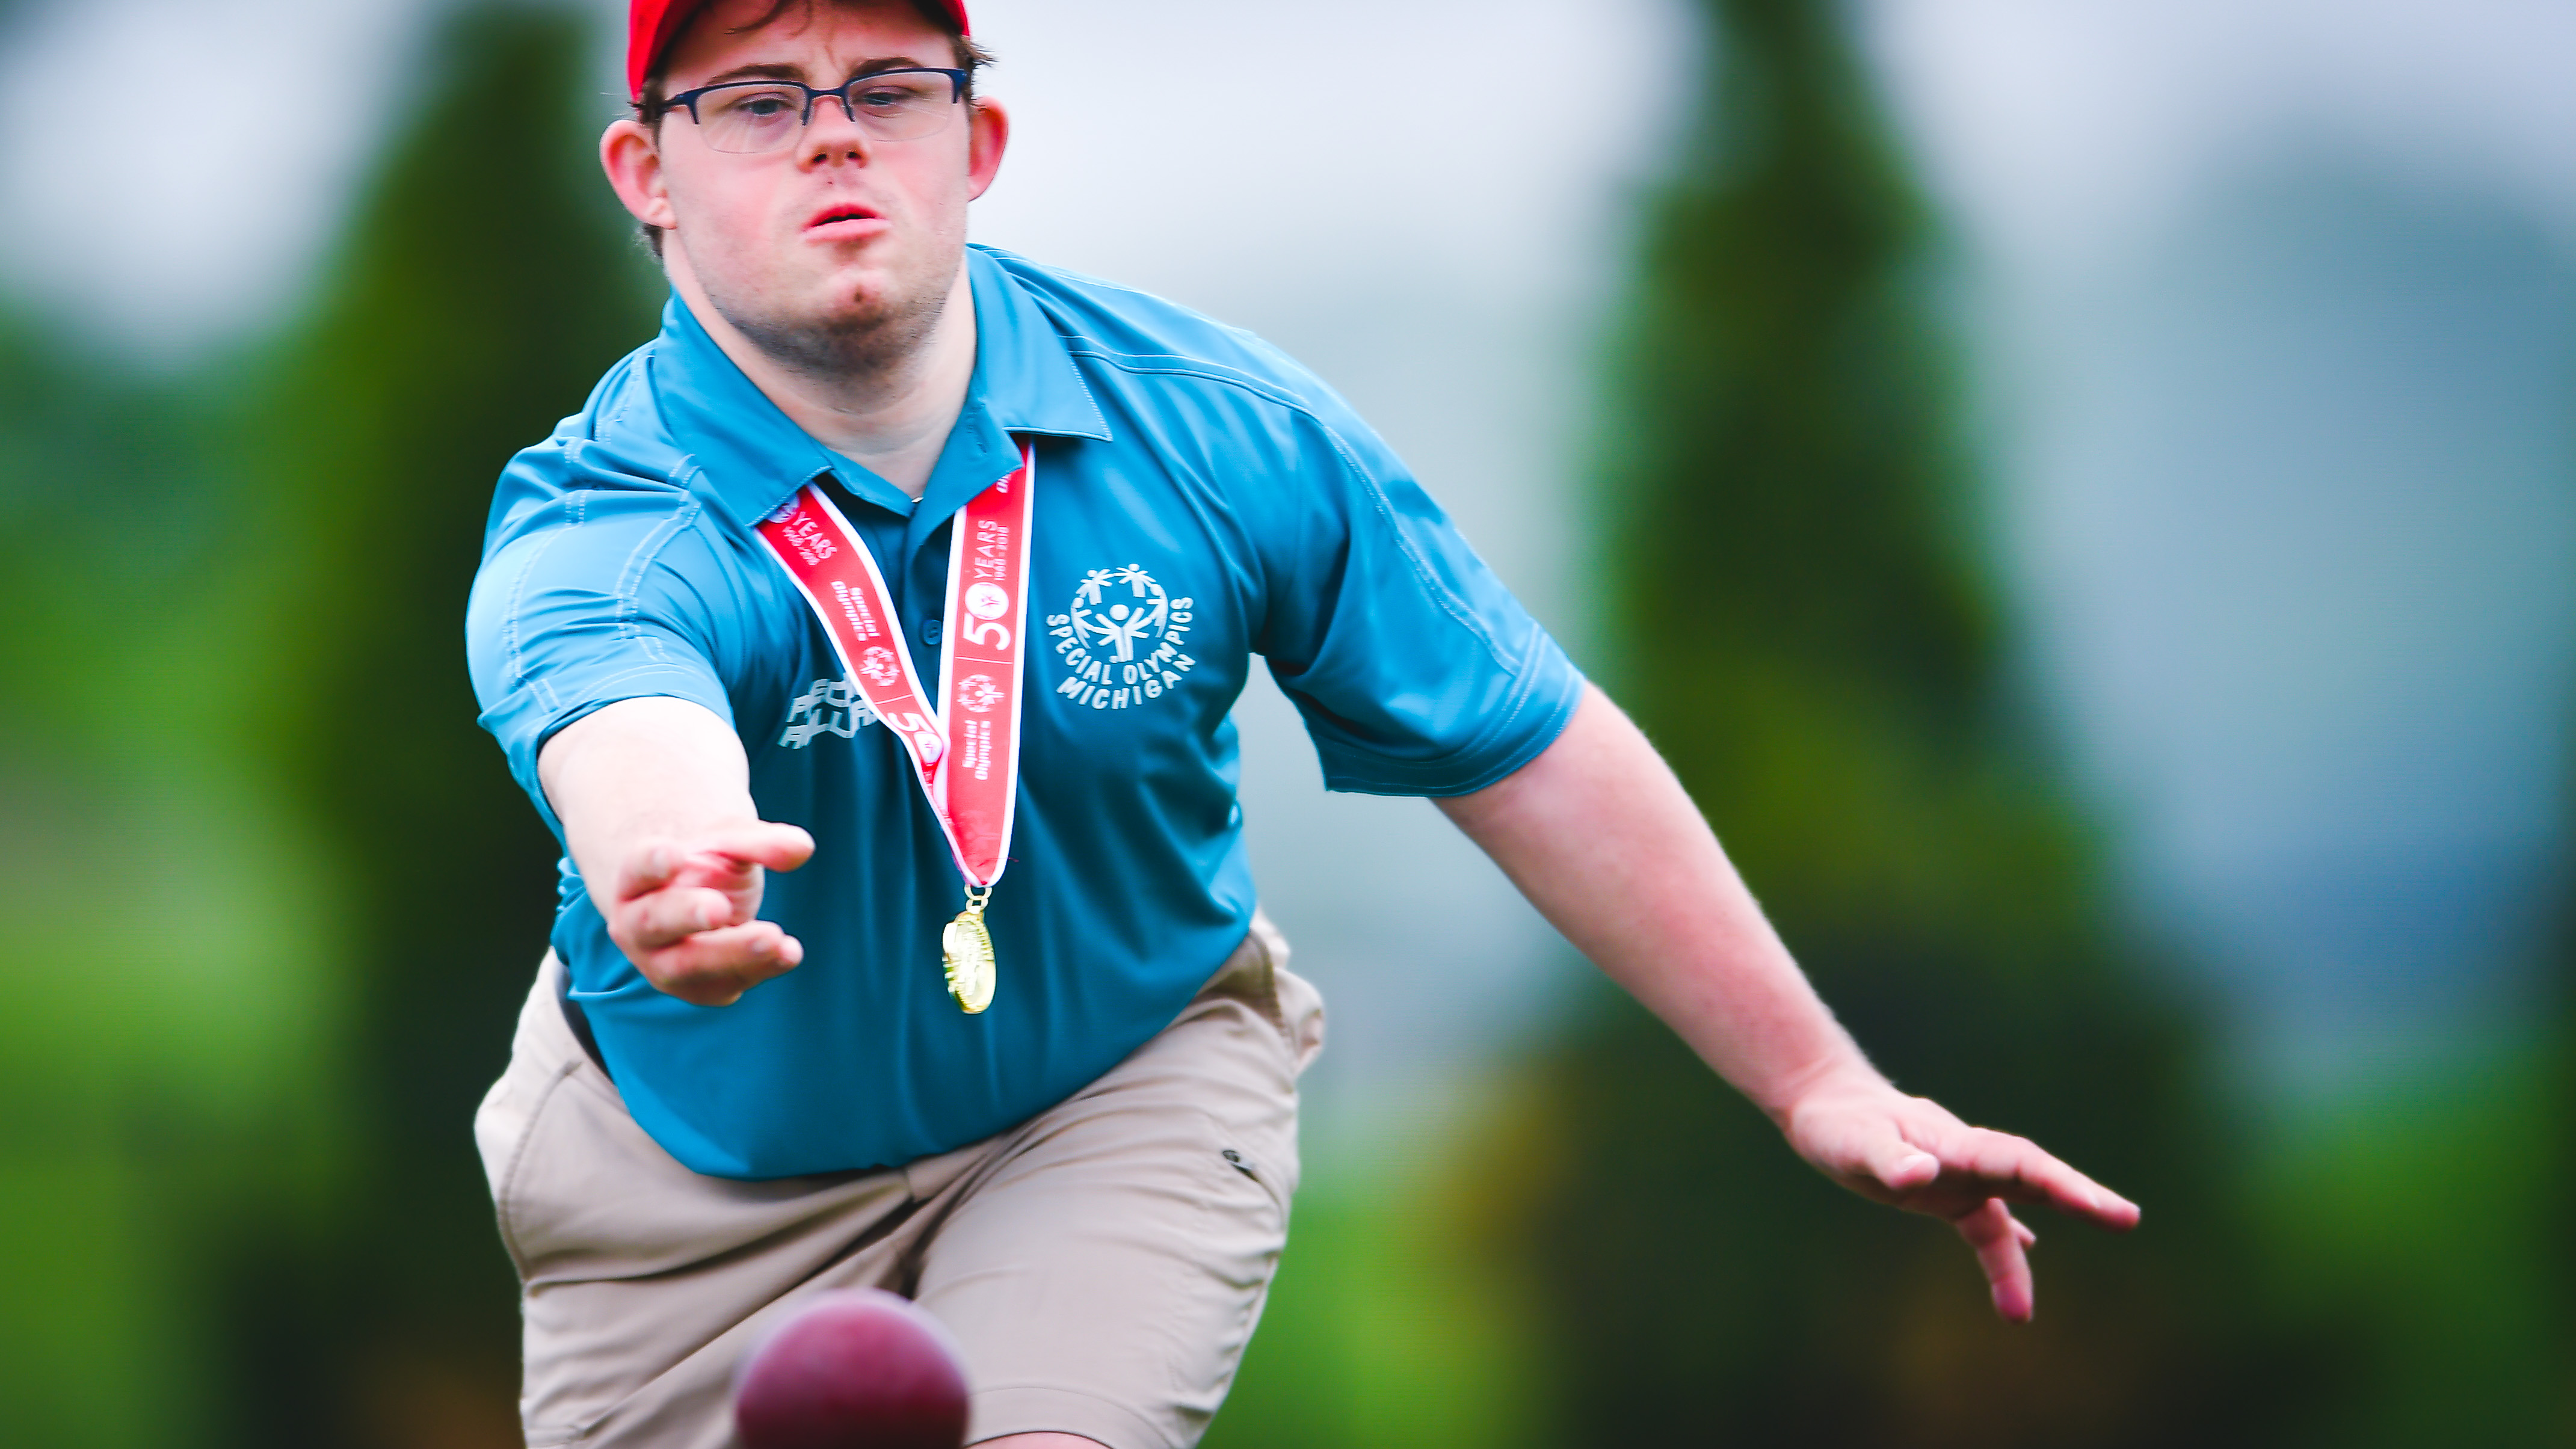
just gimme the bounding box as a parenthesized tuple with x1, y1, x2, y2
(1437, 685, 2138, 1323)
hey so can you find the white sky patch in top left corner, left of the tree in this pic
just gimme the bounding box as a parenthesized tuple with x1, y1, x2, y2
(0, 0, 420, 363)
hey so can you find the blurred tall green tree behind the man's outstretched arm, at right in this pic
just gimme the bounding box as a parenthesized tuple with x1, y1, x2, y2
(1497, 0, 2305, 1449)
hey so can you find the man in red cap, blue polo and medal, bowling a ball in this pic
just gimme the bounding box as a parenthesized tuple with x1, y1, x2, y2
(469, 0, 2136, 1449)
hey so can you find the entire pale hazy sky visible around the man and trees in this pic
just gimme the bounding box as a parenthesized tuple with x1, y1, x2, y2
(0, 0, 2576, 1125)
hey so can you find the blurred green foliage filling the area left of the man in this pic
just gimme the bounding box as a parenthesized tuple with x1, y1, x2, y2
(0, 5, 659, 1447)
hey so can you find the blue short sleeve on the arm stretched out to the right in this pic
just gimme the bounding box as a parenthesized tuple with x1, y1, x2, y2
(1246, 394, 1584, 795)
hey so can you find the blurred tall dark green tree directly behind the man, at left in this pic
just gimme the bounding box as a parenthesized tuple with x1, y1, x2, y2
(198, 2, 657, 1447)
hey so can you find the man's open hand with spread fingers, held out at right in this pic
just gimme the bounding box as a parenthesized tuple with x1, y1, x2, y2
(1778, 1068, 2138, 1323)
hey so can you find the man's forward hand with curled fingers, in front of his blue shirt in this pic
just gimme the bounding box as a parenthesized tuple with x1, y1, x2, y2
(600, 821, 814, 1006)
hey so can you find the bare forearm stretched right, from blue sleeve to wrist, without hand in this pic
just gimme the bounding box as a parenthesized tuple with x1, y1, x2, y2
(1440, 690, 1867, 1119)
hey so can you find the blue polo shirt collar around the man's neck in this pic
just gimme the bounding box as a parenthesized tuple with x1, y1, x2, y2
(655, 247, 1111, 525)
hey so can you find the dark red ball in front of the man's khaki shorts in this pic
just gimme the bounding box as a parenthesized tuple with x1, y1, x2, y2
(734, 1287, 966, 1449)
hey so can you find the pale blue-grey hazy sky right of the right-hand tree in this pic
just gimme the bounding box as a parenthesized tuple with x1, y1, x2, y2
(1867, 0, 2576, 1078)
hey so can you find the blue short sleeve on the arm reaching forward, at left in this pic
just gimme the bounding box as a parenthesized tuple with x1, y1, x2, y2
(466, 489, 734, 839)
